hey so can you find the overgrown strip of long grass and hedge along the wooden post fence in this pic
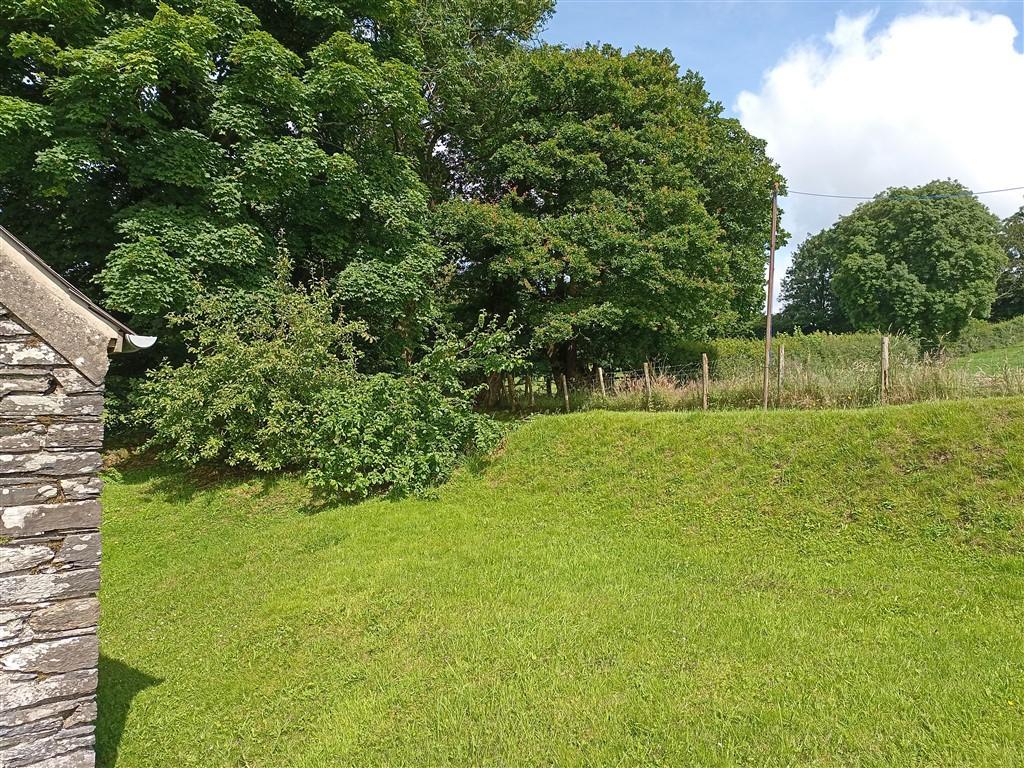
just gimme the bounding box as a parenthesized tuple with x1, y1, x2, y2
(500, 331, 1024, 414)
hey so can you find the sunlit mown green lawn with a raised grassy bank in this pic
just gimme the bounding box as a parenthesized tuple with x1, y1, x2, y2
(98, 399, 1024, 768)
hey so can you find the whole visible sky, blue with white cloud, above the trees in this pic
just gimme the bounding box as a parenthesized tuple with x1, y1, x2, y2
(543, 0, 1024, 303)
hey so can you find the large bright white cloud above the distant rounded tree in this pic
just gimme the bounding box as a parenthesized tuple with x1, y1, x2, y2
(736, 9, 1024, 303)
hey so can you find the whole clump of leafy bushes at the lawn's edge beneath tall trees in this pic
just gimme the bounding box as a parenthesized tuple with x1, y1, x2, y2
(136, 286, 515, 498)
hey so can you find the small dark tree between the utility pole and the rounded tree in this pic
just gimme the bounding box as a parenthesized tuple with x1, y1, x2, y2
(779, 229, 851, 333)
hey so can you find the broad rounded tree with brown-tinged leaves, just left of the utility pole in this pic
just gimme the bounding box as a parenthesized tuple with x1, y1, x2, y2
(435, 46, 778, 376)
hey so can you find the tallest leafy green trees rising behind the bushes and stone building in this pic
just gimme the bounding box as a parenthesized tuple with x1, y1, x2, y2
(0, 0, 551, 367)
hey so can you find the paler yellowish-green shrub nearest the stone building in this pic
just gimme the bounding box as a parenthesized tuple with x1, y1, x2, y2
(136, 286, 365, 472)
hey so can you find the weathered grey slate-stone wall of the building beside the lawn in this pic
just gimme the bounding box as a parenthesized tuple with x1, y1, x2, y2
(0, 306, 103, 768)
